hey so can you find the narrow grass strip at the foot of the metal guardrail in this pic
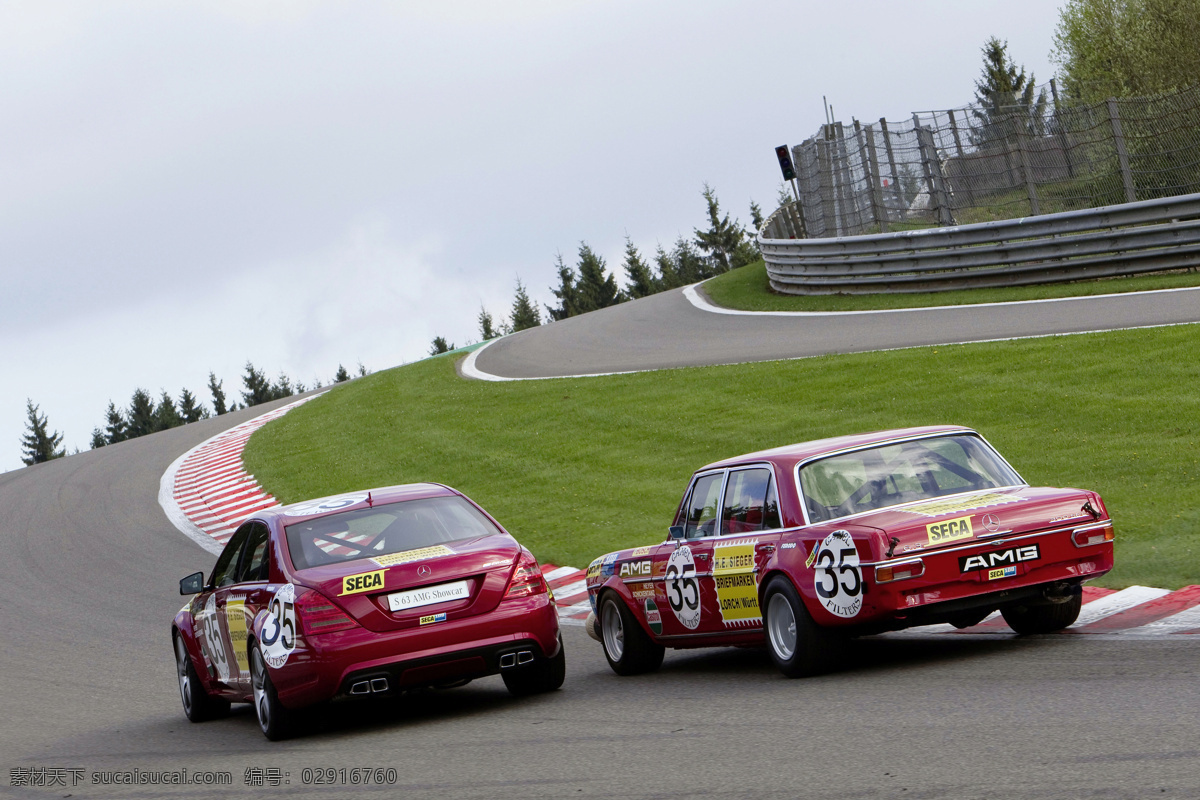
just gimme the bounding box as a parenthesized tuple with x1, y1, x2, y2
(702, 261, 1200, 311)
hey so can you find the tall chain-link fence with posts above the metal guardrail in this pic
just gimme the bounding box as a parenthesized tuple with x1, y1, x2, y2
(763, 82, 1200, 239)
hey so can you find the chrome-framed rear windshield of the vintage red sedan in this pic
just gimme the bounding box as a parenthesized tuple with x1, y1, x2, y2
(800, 435, 1024, 522)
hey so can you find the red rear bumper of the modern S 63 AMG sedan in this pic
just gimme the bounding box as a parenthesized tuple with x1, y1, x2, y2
(271, 594, 558, 708)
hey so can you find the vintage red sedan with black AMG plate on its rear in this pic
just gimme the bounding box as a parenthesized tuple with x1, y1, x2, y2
(587, 426, 1114, 676)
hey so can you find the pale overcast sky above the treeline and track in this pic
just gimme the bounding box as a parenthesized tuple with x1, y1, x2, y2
(0, 0, 1061, 469)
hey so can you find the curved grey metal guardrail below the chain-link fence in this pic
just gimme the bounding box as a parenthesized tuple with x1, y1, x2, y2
(758, 193, 1200, 295)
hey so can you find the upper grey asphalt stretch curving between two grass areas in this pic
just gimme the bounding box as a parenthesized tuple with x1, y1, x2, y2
(475, 287, 1200, 378)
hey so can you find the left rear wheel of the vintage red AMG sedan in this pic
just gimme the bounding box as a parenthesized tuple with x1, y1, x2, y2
(762, 575, 835, 678)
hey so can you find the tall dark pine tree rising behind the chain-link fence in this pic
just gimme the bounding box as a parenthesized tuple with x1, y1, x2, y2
(971, 36, 1046, 148)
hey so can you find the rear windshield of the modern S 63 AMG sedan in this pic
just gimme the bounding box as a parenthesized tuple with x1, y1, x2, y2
(287, 497, 499, 570)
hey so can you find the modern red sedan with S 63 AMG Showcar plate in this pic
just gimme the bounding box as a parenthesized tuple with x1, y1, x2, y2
(172, 483, 566, 739)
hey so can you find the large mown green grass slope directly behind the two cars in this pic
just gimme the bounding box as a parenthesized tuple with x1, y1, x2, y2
(245, 325, 1200, 588)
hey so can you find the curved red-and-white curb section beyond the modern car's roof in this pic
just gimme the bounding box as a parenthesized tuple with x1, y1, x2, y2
(158, 392, 324, 554)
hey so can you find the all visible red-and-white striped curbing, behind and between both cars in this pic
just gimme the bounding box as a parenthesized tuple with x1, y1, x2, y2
(158, 395, 1200, 638)
